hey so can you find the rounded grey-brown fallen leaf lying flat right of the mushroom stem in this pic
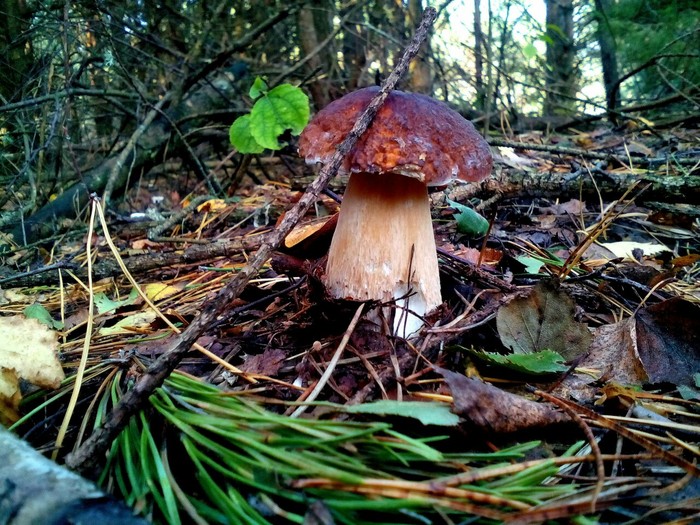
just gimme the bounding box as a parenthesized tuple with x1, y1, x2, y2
(496, 282, 591, 360)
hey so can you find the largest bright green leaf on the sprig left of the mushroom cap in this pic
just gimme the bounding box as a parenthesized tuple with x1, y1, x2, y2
(249, 84, 309, 150)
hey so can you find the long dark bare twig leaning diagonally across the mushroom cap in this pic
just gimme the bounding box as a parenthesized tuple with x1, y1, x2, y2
(66, 8, 436, 472)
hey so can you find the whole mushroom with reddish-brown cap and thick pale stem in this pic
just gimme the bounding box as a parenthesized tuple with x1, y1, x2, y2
(299, 87, 493, 337)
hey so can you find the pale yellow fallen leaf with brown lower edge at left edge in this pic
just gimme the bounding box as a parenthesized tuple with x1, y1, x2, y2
(0, 315, 65, 423)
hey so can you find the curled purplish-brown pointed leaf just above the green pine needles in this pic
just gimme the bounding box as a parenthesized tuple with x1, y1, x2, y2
(435, 367, 571, 434)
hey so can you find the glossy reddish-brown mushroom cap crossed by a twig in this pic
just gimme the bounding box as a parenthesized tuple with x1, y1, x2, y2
(299, 86, 493, 186)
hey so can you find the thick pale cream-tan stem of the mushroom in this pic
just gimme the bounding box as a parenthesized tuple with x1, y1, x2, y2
(325, 173, 442, 337)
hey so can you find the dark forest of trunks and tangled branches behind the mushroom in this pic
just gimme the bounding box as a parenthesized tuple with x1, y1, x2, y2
(0, 0, 700, 244)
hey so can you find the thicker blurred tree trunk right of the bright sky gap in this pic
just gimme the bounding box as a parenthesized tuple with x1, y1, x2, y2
(544, 0, 577, 115)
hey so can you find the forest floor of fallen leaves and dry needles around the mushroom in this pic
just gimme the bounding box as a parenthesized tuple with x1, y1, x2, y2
(0, 122, 700, 523)
